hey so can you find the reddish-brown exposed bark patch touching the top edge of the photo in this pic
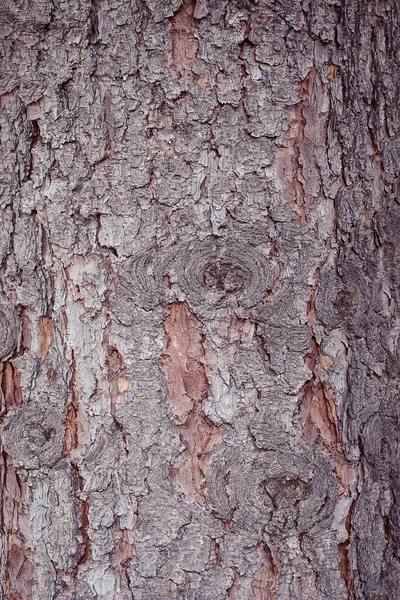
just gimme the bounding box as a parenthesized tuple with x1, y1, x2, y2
(167, 0, 199, 73)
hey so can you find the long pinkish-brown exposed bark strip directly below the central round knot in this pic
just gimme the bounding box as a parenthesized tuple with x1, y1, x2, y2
(163, 303, 222, 506)
